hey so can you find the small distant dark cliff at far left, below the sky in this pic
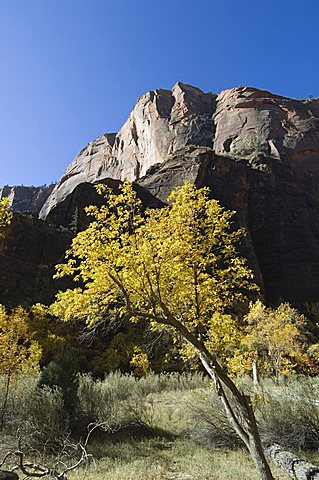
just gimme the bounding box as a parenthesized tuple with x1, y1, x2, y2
(0, 184, 54, 213)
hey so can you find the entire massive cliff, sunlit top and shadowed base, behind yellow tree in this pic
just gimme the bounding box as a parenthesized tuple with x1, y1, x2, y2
(0, 83, 319, 310)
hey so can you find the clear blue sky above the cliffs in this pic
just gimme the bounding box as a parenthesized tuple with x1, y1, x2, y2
(0, 0, 319, 185)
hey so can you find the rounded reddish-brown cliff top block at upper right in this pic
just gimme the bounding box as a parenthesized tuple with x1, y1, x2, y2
(213, 87, 319, 174)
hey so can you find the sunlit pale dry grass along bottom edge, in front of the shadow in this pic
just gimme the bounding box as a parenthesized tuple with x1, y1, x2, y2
(71, 439, 289, 480)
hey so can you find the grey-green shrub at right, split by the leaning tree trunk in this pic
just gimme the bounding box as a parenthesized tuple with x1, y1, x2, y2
(189, 376, 319, 451)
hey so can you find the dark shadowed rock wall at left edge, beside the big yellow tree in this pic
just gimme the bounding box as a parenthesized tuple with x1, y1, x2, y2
(0, 213, 71, 306)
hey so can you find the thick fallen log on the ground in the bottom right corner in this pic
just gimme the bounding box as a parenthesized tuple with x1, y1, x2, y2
(266, 444, 319, 480)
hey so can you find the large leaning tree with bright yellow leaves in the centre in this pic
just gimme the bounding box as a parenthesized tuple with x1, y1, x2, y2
(52, 182, 273, 480)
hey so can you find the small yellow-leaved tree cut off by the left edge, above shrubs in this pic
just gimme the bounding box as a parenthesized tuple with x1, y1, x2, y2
(0, 305, 41, 428)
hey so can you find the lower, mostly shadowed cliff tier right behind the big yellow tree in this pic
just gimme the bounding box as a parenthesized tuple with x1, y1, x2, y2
(139, 147, 319, 308)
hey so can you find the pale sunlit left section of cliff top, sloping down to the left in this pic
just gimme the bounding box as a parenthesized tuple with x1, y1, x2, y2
(40, 83, 215, 218)
